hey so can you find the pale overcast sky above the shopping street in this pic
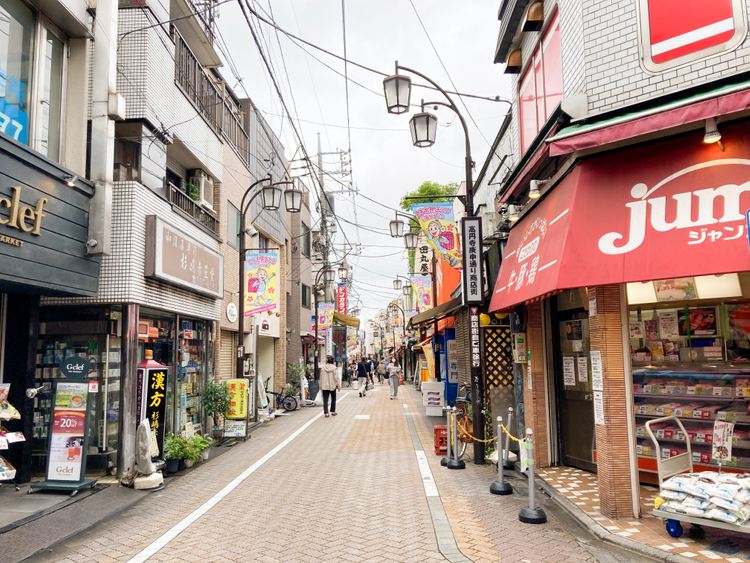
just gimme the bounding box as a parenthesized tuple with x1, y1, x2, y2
(218, 0, 509, 319)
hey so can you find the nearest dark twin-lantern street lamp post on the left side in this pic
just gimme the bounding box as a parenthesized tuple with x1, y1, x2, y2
(236, 178, 302, 416)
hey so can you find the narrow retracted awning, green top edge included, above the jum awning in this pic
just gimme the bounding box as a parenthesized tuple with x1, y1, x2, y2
(547, 79, 750, 156)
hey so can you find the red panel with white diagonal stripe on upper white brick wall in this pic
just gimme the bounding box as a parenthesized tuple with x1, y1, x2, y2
(639, 0, 745, 70)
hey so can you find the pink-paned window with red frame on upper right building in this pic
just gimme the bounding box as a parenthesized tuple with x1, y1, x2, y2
(518, 14, 562, 154)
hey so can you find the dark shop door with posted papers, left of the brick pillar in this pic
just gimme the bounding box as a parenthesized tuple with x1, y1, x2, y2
(552, 289, 596, 472)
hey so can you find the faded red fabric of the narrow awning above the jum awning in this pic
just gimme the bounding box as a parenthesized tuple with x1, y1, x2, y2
(549, 86, 750, 156)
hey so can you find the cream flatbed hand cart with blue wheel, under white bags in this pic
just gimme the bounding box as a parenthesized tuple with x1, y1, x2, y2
(646, 416, 750, 538)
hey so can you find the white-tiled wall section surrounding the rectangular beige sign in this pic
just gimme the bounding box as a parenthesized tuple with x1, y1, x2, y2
(43, 182, 220, 320)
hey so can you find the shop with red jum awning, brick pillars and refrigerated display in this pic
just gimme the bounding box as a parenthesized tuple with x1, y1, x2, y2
(490, 118, 750, 517)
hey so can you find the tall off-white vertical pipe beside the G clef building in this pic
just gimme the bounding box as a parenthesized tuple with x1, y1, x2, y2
(87, 0, 118, 254)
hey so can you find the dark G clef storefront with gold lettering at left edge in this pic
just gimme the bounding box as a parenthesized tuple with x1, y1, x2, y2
(0, 136, 100, 482)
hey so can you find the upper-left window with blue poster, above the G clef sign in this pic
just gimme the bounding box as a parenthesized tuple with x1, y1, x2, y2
(0, 0, 67, 161)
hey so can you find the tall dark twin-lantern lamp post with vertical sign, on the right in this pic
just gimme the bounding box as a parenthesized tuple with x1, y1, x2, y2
(383, 61, 484, 465)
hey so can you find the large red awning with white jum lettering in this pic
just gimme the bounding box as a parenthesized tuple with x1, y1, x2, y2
(490, 123, 750, 312)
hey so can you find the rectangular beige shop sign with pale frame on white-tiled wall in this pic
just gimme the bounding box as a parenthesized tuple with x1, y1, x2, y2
(145, 215, 224, 299)
